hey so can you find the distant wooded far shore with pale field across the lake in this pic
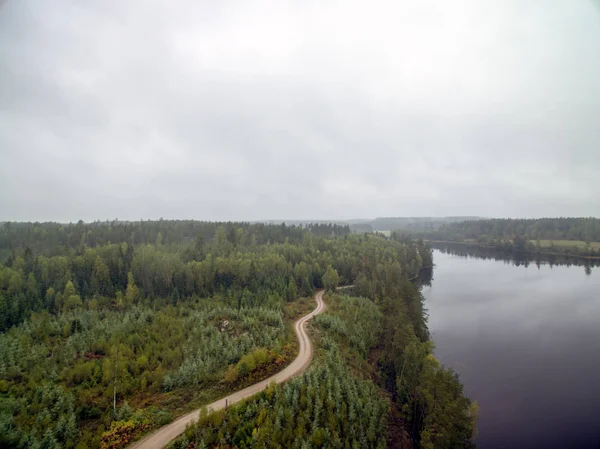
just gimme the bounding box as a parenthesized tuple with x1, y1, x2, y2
(396, 217, 600, 258)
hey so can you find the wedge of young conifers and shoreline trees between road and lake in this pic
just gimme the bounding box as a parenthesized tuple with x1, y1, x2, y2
(169, 285, 477, 449)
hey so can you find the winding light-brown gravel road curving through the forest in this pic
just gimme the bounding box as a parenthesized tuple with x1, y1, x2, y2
(130, 290, 326, 449)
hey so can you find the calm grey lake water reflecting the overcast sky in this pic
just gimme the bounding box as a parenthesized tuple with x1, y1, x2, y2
(423, 250, 600, 449)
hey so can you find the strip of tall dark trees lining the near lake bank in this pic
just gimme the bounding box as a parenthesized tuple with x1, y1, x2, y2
(354, 262, 477, 449)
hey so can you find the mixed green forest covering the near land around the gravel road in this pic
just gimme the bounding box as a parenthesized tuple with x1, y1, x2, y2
(0, 220, 474, 449)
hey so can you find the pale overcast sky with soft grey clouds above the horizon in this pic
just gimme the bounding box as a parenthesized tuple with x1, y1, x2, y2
(0, 0, 600, 222)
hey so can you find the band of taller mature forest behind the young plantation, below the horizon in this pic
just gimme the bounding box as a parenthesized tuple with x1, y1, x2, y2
(0, 221, 418, 331)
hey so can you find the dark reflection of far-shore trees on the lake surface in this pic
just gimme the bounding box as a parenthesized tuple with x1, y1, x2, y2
(430, 243, 600, 274)
